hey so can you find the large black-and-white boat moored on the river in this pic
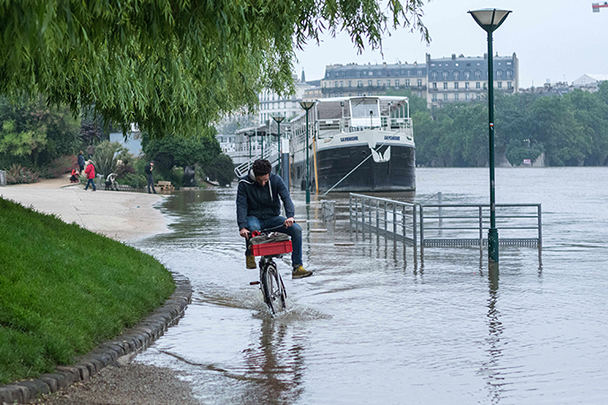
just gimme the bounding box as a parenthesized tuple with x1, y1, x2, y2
(290, 96, 416, 191)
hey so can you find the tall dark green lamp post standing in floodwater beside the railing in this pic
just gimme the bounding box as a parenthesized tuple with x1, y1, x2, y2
(469, 8, 511, 263)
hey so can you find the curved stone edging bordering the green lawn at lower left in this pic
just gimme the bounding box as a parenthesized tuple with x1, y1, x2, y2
(0, 273, 192, 404)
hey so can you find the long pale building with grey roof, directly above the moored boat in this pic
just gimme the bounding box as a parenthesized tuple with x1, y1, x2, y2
(321, 62, 427, 98)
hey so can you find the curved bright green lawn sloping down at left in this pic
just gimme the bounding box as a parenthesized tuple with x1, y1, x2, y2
(0, 198, 175, 384)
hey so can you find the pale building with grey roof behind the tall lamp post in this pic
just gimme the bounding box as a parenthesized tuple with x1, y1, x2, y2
(426, 53, 519, 108)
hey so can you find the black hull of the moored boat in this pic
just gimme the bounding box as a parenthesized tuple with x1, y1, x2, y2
(292, 145, 416, 192)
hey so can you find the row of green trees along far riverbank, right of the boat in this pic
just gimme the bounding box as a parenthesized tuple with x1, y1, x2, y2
(412, 83, 608, 166)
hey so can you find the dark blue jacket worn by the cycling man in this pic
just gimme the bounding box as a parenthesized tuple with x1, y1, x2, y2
(236, 170, 295, 230)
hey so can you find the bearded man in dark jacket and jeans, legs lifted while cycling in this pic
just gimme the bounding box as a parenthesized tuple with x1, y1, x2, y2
(236, 159, 312, 278)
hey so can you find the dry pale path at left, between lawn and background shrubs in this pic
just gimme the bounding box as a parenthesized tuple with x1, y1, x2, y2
(0, 178, 168, 241)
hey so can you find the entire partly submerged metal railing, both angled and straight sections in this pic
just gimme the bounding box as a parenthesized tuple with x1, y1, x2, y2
(349, 193, 542, 249)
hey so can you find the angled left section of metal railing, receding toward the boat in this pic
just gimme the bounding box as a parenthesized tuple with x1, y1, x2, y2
(349, 193, 417, 248)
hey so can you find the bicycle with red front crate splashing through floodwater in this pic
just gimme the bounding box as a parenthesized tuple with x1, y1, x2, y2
(249, 230, 292, 315)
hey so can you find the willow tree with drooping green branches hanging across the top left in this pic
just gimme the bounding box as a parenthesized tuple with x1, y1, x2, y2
(0, 0, 428, 134)
